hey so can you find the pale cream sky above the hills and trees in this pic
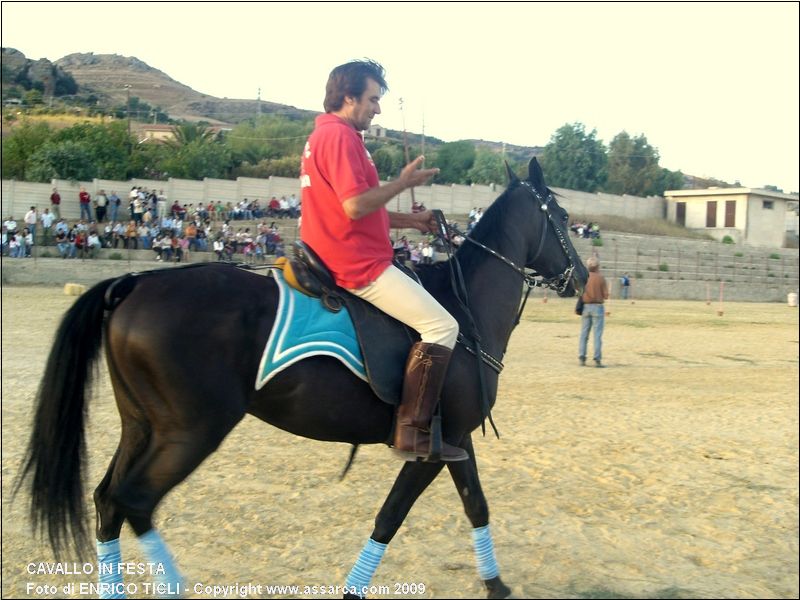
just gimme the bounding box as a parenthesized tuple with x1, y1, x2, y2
(2, 2, 800, 192)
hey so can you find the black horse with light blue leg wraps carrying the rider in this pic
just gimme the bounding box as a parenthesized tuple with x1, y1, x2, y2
(18, 159, 588, 597)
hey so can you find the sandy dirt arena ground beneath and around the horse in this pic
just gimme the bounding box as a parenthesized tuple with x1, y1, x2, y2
(2, 287, 799, 598)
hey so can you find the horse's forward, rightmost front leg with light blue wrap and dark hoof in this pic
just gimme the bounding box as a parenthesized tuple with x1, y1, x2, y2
(447, 437, 511, 598)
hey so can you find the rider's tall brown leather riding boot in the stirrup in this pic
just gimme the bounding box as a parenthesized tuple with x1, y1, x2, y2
(394, 342, 469, 462)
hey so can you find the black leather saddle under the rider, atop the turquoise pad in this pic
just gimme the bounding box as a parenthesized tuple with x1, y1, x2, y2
(276, 240, 420, 406)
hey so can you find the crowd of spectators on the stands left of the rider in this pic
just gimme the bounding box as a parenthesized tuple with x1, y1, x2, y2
(2, 187, 300, 263)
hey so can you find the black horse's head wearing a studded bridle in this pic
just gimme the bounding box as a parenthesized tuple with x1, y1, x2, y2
(507, 158, 589, 297)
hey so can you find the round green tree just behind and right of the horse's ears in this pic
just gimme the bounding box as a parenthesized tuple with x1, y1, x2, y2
(540, 123, 607, 192)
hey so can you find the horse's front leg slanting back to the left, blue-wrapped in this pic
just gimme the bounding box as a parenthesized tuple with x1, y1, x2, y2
(344, 462, 444, 598)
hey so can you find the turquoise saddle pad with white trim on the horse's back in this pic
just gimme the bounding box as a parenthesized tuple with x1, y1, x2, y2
(256, 269, 367, 390)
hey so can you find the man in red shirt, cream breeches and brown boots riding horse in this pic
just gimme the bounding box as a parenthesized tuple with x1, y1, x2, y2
(300, 60, 468, 461)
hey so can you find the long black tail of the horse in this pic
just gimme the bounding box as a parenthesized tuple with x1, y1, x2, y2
(14, 279, 126, 556)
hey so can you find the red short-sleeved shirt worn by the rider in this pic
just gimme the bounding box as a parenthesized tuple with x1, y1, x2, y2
(300, 114, 393, 289)
